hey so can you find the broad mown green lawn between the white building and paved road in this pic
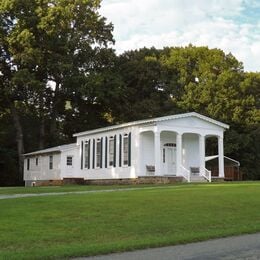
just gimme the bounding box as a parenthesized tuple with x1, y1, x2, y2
(0, 182, 260, 259)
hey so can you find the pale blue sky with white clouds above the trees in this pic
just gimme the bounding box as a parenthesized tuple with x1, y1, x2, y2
(100, 0, 260, 71)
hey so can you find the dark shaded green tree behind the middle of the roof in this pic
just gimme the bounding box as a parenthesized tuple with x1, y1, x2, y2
(112, 48, 176, 122)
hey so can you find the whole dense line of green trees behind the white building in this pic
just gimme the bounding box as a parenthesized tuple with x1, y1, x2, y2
(0, 0, 260, 185)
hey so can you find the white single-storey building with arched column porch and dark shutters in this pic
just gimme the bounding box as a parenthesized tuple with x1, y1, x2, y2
(24, 112, 229, 186)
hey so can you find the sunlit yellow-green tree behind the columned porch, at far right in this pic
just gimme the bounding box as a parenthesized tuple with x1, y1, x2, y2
(162, 45, 260, 178)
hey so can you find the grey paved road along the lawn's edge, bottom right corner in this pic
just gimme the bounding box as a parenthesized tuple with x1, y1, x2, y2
(77, 233, 260, 260)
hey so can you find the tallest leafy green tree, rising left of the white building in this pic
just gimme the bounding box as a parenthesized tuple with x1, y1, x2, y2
(0, 0, 113, 183)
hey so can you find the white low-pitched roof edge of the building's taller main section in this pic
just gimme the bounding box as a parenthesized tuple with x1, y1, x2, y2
(73, 112, 229, 137)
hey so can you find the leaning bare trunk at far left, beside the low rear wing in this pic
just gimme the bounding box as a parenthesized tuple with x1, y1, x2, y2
(10, 104, 24, 181)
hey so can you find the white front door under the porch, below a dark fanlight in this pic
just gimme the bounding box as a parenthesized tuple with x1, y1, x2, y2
(163, 147, 176, 175)
